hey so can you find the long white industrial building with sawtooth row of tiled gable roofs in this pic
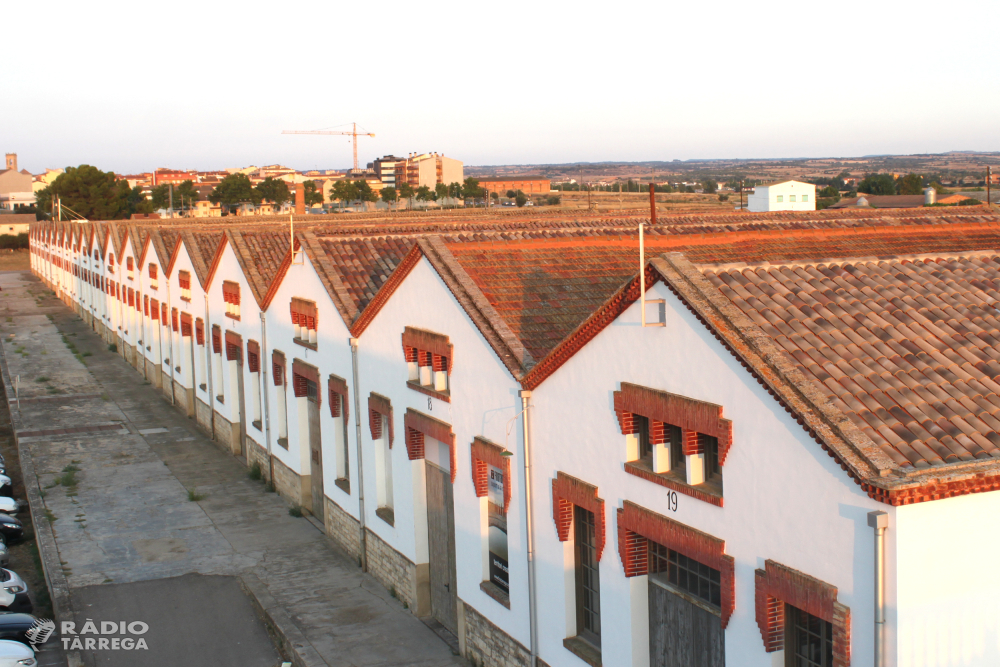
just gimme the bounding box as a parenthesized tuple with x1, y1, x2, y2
(30, 209, 1000, 667)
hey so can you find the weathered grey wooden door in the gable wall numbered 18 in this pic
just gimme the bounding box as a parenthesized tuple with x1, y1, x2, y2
(425, 461, 458, 634)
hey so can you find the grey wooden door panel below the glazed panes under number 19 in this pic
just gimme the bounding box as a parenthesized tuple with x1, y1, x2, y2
(649, 575, 726, 667)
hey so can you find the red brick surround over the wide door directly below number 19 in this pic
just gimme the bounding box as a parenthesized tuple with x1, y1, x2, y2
(618, 500, 736, 629)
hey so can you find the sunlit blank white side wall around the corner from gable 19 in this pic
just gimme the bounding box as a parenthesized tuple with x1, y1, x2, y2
(896, 491, 1000, 667)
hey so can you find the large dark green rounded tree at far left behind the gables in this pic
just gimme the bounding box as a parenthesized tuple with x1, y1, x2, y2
(35, 164, 139, 220)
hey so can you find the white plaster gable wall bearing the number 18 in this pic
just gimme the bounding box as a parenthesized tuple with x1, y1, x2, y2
(360, 258, 529, 646)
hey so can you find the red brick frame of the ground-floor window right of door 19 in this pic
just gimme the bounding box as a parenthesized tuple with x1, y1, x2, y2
(754, 559, 851, 667)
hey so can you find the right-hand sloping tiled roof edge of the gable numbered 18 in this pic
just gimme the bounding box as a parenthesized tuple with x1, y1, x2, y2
(417, 236, 535, 382)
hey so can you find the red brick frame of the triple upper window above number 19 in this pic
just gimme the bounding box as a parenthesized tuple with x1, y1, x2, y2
(613, 382, 733, 507)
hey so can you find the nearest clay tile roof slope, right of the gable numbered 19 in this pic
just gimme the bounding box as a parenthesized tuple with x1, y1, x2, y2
(703, 249, 1000, 469)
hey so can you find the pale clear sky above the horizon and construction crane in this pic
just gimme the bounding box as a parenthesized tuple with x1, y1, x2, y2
(0, 0, 1000, 173)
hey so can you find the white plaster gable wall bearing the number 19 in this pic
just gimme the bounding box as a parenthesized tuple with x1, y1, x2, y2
(531, 284, 895, 667)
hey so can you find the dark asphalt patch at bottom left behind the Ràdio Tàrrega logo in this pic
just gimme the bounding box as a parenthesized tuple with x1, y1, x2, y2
(69, 574, 281, 667)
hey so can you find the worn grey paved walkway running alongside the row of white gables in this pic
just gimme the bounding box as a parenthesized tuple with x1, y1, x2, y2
(0, 273, 467, 666)
